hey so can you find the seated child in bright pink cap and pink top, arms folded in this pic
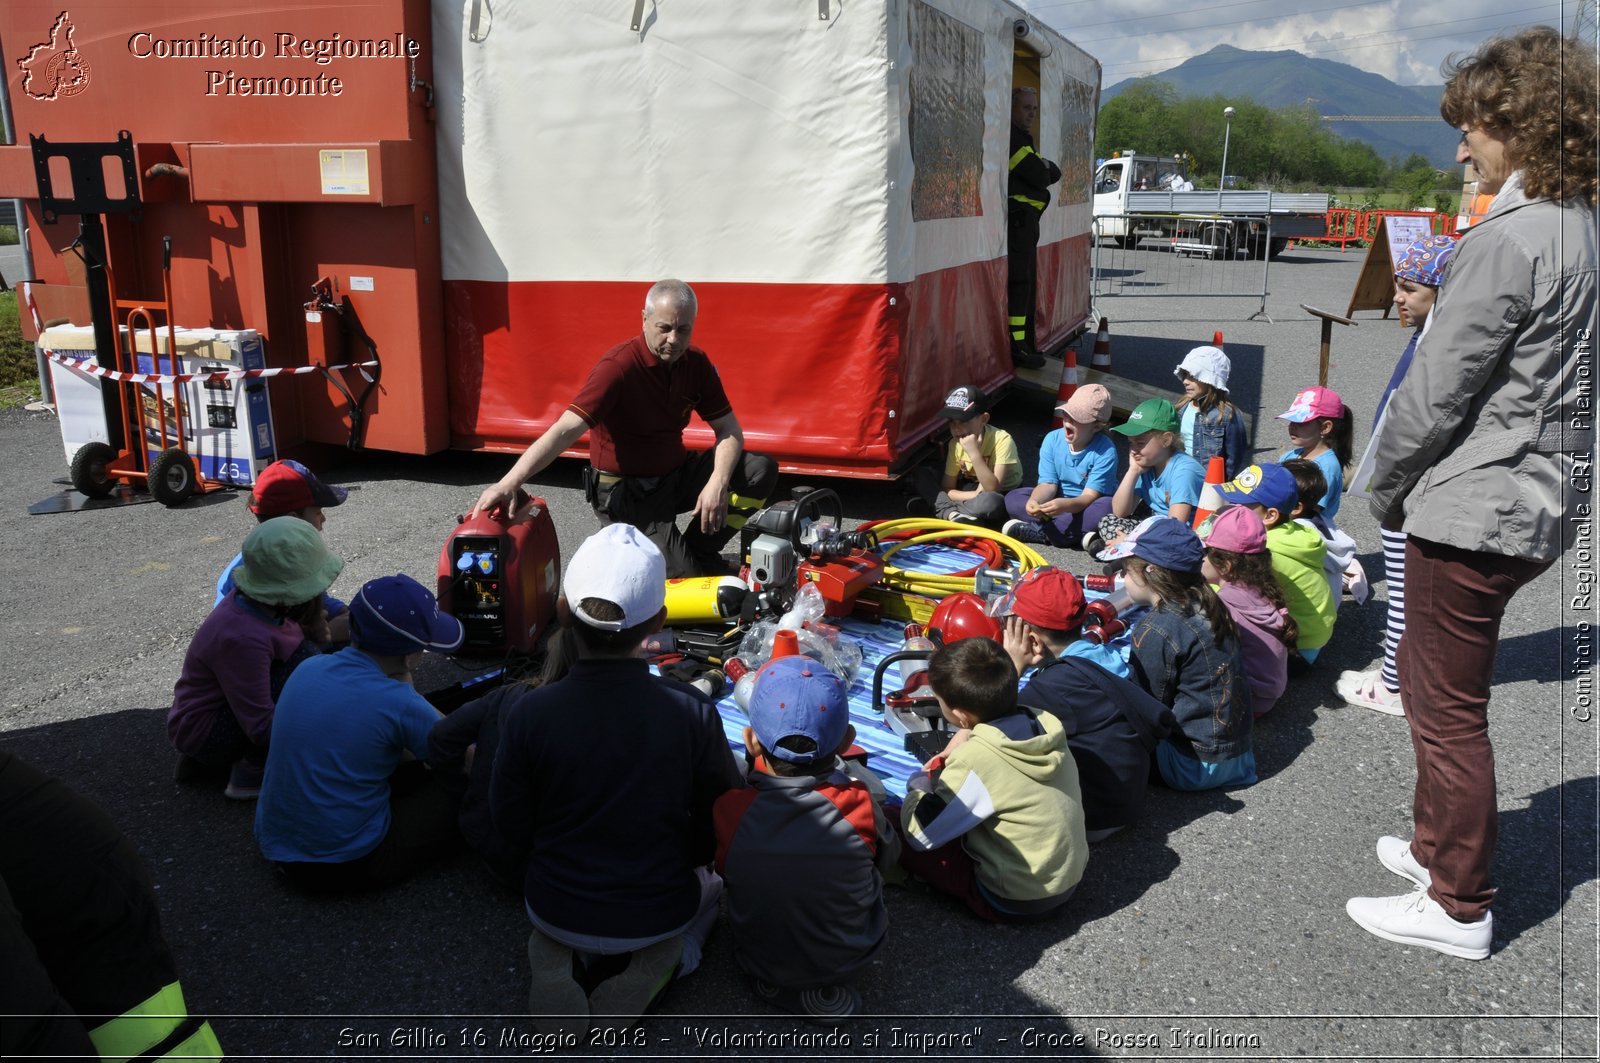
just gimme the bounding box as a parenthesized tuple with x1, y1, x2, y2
(1200, 505, 1292, 717)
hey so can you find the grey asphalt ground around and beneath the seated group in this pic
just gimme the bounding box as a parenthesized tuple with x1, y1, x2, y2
(0, 250, 1597, 1060)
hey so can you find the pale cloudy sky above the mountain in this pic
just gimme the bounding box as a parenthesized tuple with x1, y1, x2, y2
(1016, 0, 1579, 86)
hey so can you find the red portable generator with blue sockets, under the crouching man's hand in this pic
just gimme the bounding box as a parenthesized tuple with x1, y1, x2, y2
(438, 491, 562, 656)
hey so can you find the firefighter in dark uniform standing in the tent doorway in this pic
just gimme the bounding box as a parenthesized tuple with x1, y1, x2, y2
(1006, 88, 1061, 370)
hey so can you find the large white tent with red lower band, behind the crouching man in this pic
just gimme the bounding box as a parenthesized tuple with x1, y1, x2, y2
(434, 0, 1099, 475)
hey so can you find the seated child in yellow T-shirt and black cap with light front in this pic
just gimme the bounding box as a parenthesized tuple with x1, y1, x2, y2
(914, 384, 1022, 528)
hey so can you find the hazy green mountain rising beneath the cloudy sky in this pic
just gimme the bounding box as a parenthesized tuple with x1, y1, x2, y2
(1101, 45, 1459, 170)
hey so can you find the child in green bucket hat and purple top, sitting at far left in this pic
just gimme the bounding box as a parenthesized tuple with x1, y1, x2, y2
(166, 517, 344, 800)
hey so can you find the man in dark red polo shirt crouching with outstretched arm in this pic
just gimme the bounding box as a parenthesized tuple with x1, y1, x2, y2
(472, 280, 778, 578)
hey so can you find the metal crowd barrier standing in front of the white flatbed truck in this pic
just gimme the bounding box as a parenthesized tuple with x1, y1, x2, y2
(1093, 215, 1272, 323)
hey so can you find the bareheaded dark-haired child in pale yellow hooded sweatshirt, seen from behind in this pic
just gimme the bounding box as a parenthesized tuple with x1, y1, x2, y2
(901, 639, 1088, 922)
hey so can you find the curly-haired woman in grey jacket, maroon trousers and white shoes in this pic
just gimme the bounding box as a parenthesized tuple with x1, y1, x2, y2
(1346, 27, 1597, 959)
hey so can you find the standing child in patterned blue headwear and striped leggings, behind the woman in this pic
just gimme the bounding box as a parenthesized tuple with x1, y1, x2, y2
(1334, 235, 1456, 716)
